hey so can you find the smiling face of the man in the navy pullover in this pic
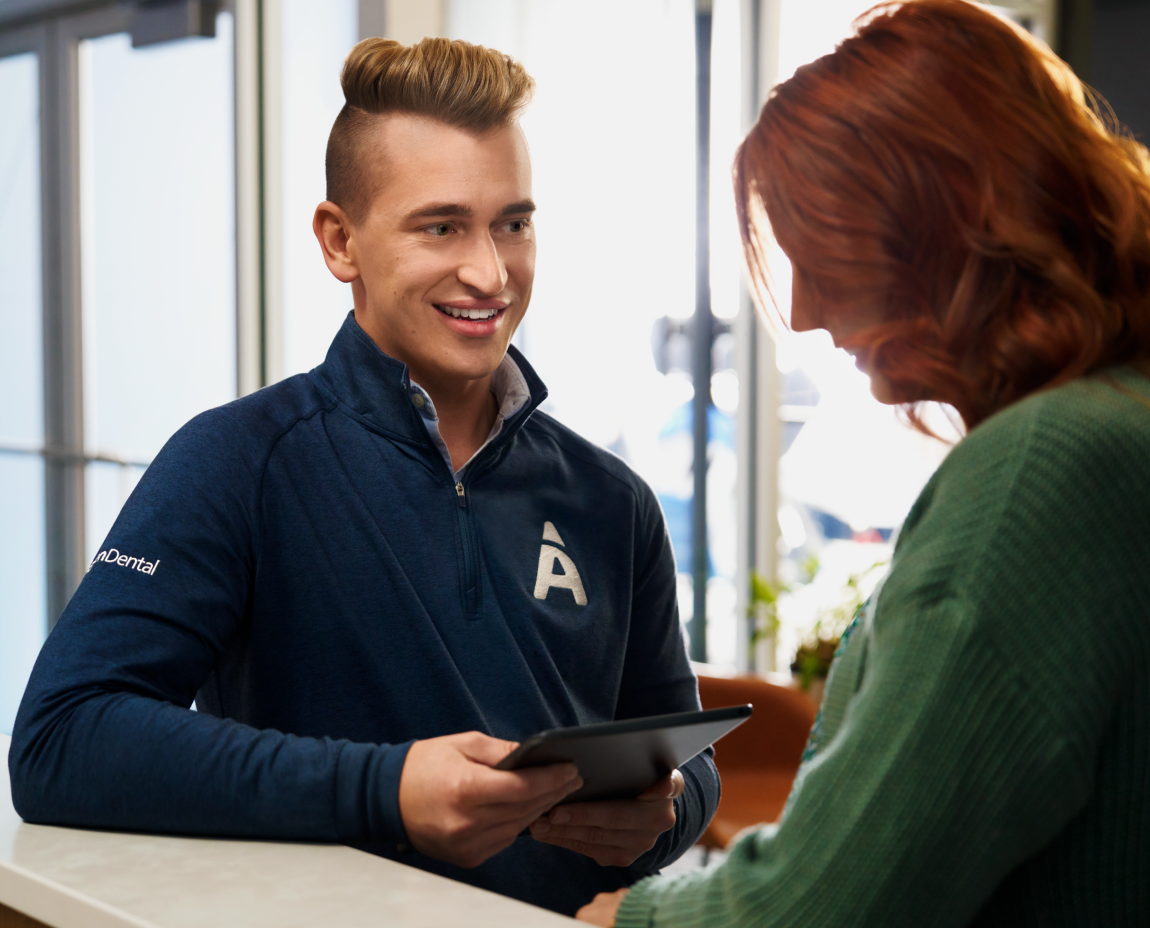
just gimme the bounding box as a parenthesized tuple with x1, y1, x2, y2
(347, 115, 535, 390)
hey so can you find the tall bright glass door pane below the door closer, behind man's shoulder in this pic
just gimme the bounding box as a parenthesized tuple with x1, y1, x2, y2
(77, 13, 236, 560)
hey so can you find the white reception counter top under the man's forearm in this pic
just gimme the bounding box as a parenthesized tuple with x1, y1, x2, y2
(0, 735, 576, 928)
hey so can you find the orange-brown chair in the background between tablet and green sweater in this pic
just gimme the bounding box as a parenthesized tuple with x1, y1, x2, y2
(699, 676, 815, 850)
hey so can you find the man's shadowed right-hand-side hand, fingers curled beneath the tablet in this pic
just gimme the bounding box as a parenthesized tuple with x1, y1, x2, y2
(531, 770, 683, 867)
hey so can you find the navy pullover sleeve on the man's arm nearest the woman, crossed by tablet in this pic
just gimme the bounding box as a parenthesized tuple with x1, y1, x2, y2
(616, 483, 719, 876)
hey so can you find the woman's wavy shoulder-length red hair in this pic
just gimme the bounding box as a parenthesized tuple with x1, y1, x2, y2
(734, 0, 1150, 430)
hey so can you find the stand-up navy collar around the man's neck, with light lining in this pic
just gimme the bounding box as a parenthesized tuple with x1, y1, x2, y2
(308, 310, 547, 473)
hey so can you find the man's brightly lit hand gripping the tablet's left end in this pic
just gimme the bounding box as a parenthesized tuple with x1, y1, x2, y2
(399, 731, 583, 867)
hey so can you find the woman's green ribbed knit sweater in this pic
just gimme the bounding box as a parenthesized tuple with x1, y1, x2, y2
(616, 370, 1150, 928)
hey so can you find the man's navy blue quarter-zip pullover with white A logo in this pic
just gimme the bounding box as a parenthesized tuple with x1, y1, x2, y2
(9, 315, 719, 913)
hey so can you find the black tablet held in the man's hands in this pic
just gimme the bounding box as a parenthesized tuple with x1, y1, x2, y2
(496, 705, 753, 803)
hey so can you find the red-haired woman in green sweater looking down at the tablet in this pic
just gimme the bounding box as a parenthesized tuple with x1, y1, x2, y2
(581, 0, 1150, 928)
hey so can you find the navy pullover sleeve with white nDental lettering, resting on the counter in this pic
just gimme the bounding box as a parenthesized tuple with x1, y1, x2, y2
(8, 407, 407, 843)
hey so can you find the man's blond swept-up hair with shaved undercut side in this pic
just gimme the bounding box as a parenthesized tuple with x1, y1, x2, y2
(325, 38, 535, 222)
